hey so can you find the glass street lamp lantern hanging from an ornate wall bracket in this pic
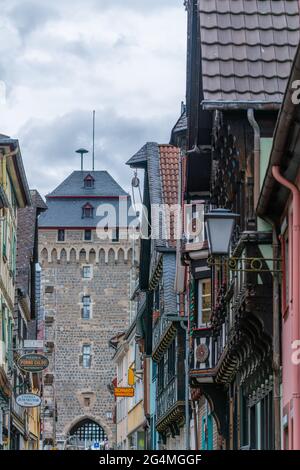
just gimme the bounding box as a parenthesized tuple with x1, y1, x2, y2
(204, 209, 238, 256)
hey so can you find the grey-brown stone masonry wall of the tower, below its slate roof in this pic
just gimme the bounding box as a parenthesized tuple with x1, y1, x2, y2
(39, 229, 132, 446)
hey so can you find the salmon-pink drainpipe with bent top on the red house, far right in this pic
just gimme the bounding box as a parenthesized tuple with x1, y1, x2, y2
(272, 165, 300, 450)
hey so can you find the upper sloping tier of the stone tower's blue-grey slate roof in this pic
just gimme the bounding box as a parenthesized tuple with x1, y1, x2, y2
(46, 171, 128, 198)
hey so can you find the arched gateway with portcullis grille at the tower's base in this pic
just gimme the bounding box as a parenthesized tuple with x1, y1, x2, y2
(69, 418, 107, 449)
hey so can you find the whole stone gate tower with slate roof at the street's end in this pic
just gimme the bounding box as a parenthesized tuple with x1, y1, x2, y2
(39, 171, 134, 448)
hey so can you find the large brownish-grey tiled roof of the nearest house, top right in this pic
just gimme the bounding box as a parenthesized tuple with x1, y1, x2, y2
(198, 0, 299, 108)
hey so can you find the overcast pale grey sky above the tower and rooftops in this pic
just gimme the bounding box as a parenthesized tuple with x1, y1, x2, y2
(0, 0, 186, 195)
